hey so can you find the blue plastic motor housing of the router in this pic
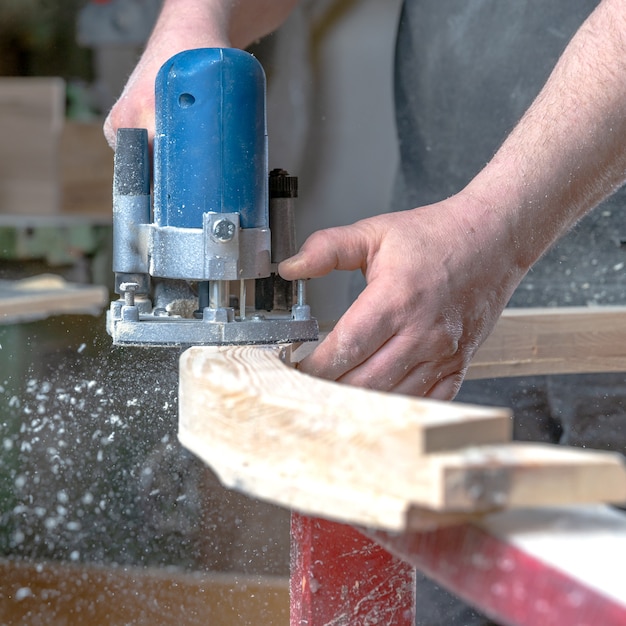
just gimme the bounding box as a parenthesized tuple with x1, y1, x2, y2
(154, 48, 268, 228)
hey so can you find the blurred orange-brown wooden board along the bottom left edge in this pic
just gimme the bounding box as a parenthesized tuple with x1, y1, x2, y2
(0, 559, 289, 626)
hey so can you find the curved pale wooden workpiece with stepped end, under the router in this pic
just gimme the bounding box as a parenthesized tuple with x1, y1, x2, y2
(179, 346, 626, 530)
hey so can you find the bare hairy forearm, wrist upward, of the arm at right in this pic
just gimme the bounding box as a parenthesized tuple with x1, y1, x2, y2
(465, 0, 626, 268)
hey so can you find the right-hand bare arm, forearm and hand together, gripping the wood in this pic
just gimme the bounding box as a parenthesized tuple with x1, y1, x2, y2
(279, 0, 626, 399)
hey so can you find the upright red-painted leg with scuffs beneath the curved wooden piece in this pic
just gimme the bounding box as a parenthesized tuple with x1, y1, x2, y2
(290, 513, 415, 626)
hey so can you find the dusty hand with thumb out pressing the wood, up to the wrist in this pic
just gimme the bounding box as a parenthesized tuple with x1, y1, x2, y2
(279, 189, 525, 399)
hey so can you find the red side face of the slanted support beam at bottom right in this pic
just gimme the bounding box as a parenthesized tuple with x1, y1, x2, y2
(368, 524, 626, 626)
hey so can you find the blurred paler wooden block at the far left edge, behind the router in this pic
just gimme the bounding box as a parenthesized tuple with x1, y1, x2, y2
(0, 77, 65, 215)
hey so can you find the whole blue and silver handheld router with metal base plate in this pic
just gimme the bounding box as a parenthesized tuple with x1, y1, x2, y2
(107, 48, 318, 346)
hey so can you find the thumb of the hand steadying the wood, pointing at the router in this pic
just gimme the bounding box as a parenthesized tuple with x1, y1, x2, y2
(278, 223, 372, 280)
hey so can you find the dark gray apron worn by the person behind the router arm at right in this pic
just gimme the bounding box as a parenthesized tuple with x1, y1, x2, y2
(391, 0, 626, 626)
